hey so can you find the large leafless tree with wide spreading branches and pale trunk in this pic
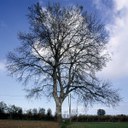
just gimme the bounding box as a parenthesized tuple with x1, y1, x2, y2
(7, 3, 120, 121)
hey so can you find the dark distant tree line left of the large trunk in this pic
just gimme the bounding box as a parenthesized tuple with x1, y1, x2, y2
(0, 102, 56, 120)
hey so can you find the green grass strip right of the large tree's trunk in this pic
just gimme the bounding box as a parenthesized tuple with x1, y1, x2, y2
(67, 122, 128, 128)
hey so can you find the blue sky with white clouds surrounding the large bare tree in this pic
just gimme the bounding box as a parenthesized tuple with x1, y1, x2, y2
(0, 0, 128, 115)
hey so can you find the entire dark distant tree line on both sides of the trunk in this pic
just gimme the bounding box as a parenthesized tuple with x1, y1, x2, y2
(0, 102, 128, 122)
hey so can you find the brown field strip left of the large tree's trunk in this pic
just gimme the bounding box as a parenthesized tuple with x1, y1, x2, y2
(0, 120, 58, 128)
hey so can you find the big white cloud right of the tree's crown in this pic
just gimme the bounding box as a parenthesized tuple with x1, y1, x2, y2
(101, 0, 128, 79)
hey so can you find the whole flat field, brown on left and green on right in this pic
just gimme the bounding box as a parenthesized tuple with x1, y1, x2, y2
(0, 120, 128, 128)
